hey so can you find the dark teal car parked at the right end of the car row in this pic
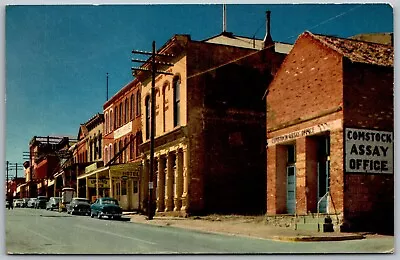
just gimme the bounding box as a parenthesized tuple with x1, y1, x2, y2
(90, 197, 122, 219)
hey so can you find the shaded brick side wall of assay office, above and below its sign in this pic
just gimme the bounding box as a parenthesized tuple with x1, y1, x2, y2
(344, 61, 394, 232)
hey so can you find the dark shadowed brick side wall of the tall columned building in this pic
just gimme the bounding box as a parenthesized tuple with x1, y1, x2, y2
(187, 41, 275, 213)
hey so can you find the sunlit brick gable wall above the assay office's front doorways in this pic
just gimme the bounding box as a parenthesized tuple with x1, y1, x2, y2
(267, 35, 343, 129)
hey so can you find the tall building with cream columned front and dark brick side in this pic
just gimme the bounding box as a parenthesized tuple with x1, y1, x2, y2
(135, 17, 285, 214)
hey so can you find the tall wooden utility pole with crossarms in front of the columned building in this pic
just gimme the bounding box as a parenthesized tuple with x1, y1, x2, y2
(132, 41, 174, 220)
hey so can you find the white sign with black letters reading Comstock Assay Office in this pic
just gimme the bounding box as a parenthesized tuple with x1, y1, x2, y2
(345, 128, 394, 173)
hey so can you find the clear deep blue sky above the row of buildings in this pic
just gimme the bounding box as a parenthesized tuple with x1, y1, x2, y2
(5, 4, 393, 177)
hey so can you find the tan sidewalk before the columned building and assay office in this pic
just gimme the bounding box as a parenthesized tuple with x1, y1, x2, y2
(124, 212, 365, 242)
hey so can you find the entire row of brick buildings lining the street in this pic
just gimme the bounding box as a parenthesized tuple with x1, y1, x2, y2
(16, 12, 394, 233)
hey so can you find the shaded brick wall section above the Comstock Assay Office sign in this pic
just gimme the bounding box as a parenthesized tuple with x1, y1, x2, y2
(343, 60, 394, 131)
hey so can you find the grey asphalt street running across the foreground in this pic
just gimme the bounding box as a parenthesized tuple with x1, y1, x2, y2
(5, 208, 394, 254)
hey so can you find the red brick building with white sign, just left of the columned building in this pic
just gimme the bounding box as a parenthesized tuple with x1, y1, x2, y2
(103, 80, 142, 210)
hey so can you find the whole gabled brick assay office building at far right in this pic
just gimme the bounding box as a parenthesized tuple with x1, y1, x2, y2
(266, 32, 394, 233)
